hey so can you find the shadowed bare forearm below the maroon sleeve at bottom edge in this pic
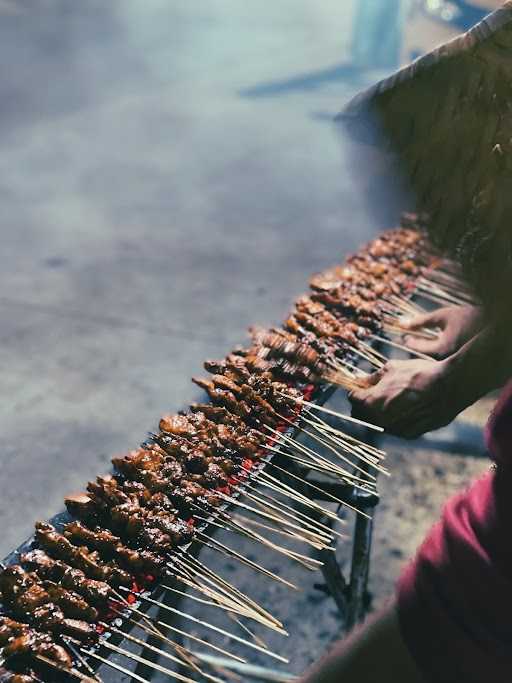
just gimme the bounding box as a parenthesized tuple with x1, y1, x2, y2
(300, 604, 424, 683)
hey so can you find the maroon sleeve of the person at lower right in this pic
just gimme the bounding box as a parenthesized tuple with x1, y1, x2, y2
(398, 382, 512, 683)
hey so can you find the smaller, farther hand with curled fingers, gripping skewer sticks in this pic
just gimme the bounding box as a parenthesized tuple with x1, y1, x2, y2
(402, 305, 483, 359)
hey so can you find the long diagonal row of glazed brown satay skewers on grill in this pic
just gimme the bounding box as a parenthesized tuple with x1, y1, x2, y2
(0, 218, 476, 683)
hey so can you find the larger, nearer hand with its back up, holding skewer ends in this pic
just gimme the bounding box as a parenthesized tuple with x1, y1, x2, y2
(349, 360, 456, 439)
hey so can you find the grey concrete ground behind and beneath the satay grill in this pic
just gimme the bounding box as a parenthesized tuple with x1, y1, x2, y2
(0, 0, 496, 680)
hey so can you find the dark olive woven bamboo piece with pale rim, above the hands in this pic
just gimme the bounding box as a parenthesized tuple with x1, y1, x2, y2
(338, 2, 512, 308)
